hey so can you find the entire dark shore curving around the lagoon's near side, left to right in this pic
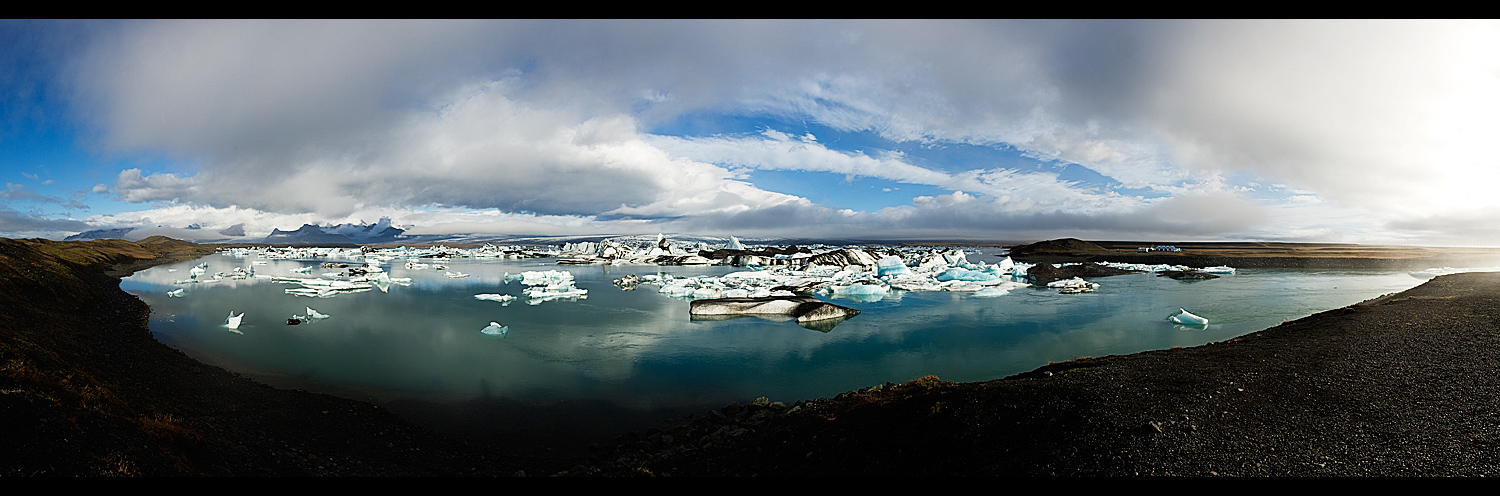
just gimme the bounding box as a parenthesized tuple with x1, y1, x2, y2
(0, 238, 1500, 477)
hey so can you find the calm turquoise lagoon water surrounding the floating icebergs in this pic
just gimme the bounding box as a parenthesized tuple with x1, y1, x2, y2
(122, 255, 1422, 409)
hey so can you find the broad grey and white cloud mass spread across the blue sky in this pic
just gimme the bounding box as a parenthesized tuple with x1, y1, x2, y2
(58, 21, 1500, 247)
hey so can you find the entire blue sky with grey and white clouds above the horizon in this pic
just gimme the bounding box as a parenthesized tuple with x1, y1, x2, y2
(0, 19, 1500, 246)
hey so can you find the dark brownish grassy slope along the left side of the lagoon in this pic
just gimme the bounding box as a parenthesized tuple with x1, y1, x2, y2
(0, 238, 567, 475)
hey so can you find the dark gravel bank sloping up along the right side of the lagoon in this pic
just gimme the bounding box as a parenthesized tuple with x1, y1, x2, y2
(569, 273, 1500, 477)
